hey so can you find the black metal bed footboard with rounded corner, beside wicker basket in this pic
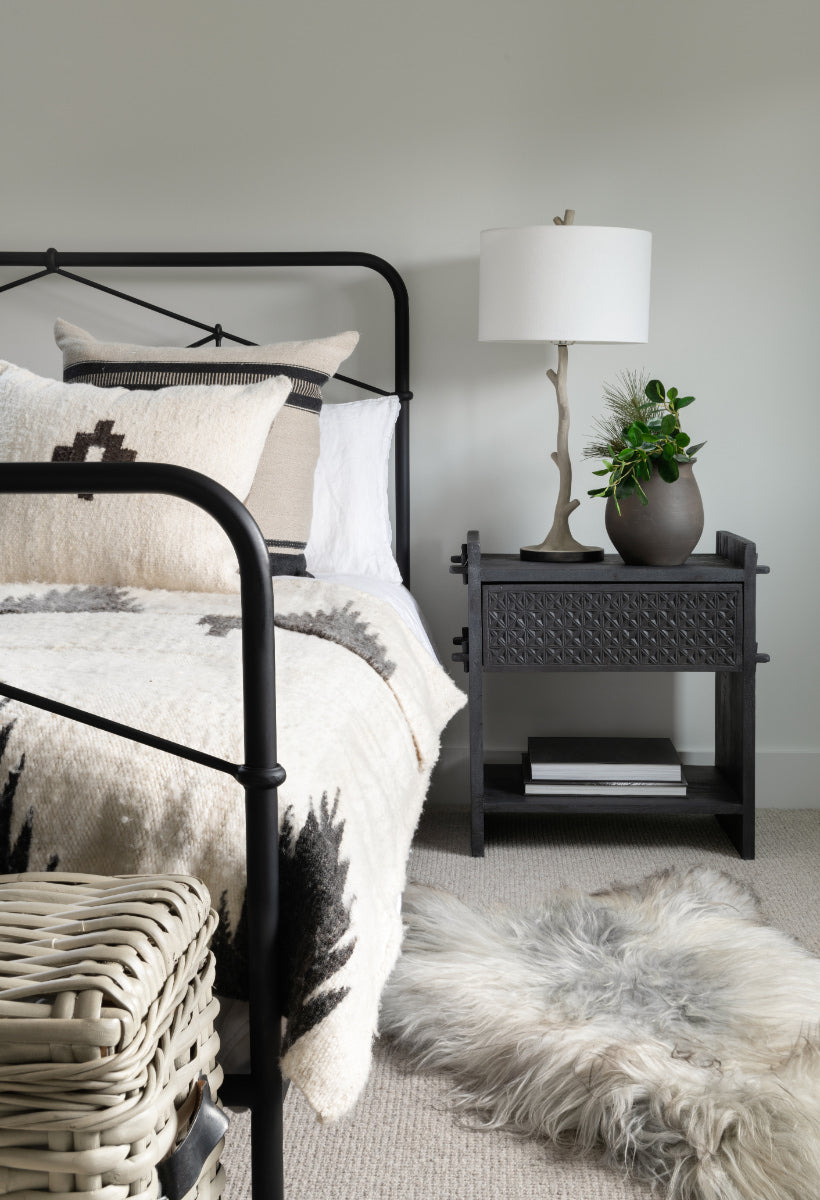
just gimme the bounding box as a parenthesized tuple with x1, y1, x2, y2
(0, 462, 285, 1200)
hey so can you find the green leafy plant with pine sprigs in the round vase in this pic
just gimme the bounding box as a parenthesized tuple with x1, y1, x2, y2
(583, 371, 706, 512)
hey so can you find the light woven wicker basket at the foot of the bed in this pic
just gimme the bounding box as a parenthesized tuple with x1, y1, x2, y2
(0, 874, 223, 1200)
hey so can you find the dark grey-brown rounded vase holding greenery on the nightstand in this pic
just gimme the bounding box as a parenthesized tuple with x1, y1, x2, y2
(606, 462, 704, 566)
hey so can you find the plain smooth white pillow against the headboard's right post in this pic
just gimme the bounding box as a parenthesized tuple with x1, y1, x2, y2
(305, 396, 401, 583)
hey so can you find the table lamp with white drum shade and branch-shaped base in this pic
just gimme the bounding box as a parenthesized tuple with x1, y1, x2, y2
(478, 209, 652, 563)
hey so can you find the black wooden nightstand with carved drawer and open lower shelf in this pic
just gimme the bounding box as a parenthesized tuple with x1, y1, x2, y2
(450, 530, 768, 858)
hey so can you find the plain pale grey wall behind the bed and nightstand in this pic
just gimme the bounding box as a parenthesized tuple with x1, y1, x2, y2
(0, 0, 820, 805)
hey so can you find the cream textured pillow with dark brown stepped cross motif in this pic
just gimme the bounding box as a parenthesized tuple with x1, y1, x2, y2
(0, 361, 291, 592)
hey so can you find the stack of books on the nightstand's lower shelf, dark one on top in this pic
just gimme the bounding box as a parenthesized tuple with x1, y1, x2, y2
(522, 738, 687, 797)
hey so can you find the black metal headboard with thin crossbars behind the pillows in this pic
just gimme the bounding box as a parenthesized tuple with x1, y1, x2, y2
(0, 248, 413, 587)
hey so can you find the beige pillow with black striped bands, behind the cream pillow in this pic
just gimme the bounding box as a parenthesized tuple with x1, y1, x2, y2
(54, 320, 359, 575)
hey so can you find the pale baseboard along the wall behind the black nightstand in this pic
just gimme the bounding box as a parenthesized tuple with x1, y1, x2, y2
(427, 746, 820, 809)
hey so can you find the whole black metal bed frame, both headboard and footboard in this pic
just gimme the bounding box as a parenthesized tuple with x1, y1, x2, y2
(0, 250, 412, 1200)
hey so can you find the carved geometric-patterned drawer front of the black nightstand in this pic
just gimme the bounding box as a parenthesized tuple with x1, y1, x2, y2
(481, 583, 743, 671)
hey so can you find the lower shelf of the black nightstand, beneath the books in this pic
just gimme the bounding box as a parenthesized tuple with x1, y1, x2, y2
(484, 763, 743, 816)
